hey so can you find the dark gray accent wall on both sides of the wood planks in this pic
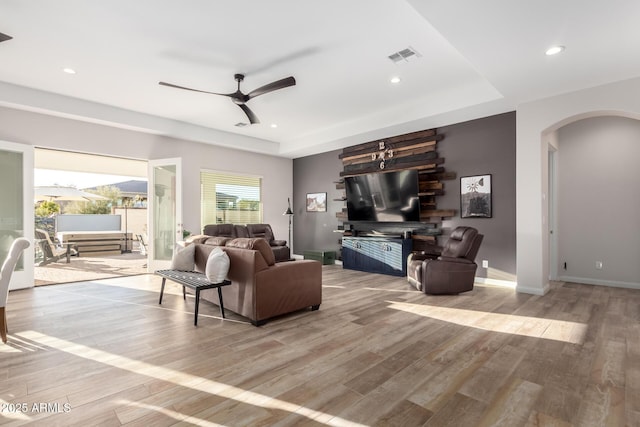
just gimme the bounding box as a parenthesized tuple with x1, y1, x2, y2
(293, 112, 516, 282)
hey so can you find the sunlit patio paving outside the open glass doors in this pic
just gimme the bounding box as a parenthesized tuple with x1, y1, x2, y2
(34, 241, 147, 286)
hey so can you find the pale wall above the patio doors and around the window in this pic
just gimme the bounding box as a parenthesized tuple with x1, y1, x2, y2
(0, 107, 293, 244)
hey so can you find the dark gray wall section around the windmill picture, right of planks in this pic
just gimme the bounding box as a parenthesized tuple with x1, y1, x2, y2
(438, 112, 516, 282)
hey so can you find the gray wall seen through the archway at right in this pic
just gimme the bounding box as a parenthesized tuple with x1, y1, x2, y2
(557, 116, 640, 289)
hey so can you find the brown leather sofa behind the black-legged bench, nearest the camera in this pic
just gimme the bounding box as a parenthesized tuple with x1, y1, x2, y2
(194, 236, 322, 326)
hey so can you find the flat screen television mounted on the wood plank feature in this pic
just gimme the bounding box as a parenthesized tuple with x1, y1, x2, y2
(344, 170, 420, 222)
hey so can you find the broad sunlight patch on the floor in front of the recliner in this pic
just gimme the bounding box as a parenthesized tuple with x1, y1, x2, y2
(387, 301, 587, 344)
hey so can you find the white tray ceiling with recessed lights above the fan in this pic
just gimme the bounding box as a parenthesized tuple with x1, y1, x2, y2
(0, 0, 640, 158)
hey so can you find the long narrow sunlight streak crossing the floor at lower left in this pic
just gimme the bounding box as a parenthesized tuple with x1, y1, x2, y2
(17, 331, 364, 427)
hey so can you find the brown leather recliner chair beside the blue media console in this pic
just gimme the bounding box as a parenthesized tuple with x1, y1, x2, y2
(407, 227, 484, 295)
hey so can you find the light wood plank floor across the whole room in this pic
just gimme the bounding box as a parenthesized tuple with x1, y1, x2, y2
(0, 266, 640, 426)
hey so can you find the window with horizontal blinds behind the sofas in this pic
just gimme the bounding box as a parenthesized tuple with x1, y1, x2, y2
(200, 171, 262, 228)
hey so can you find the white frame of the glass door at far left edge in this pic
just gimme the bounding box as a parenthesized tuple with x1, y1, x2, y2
(0, 140, 35, 290)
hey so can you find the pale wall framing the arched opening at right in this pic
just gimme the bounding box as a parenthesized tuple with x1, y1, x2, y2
(516, 79, 640, 295)
